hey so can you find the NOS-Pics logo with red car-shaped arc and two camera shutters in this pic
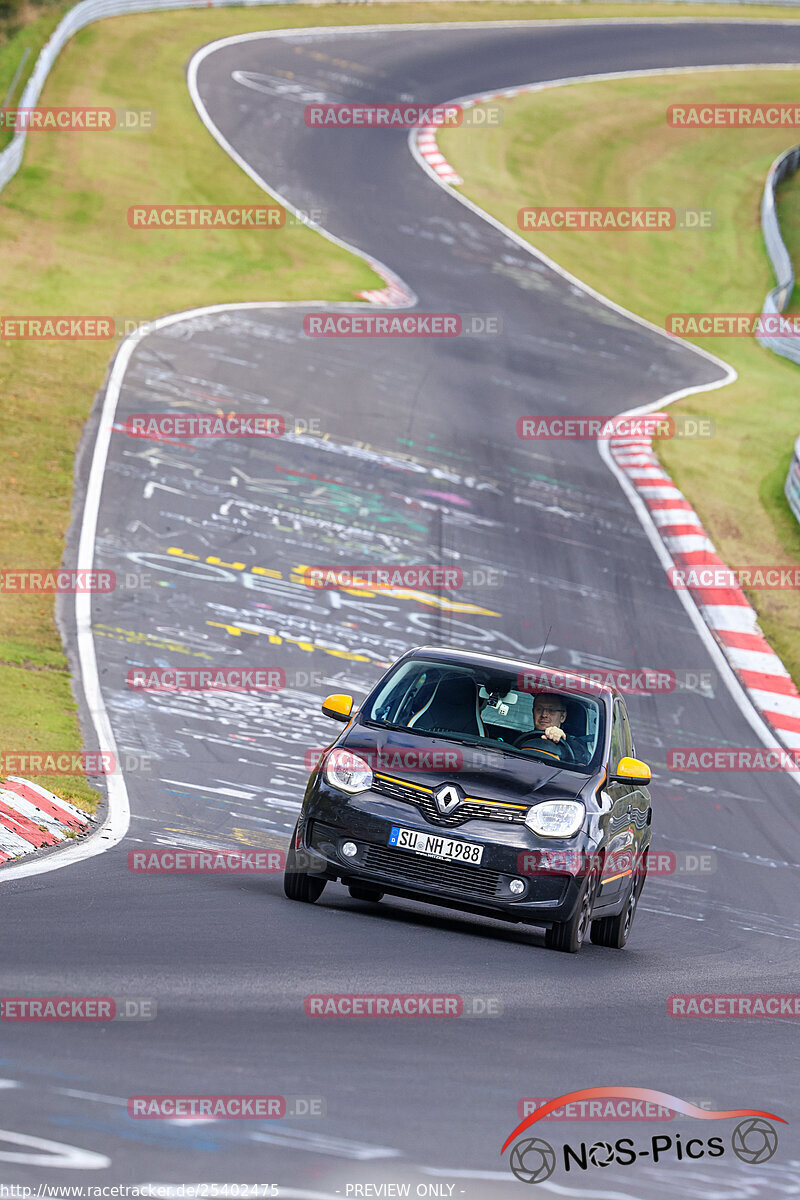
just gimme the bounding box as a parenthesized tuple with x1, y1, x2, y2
(500, 1087, 786, 1183)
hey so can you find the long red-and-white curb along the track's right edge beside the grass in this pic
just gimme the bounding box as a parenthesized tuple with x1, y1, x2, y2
(610, 422, 800, 750)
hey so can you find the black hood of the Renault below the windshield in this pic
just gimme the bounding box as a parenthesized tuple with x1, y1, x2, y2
(337, 725, 593, 804)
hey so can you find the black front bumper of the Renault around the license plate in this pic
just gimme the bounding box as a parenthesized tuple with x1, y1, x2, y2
(300, 779, 593, 925)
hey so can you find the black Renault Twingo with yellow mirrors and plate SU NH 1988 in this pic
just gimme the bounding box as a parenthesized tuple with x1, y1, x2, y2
(284, 647, 652, 953)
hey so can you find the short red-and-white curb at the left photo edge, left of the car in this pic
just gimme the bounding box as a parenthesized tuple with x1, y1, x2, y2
(0, 775, 94, 865)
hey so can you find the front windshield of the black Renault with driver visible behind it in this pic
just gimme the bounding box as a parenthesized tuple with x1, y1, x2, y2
(362, 659, 603, 773)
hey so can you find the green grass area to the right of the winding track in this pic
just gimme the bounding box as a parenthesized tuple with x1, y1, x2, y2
(439, 70, 800, 683)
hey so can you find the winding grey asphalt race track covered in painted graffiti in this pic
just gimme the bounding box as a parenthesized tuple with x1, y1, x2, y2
(0, 23, 800, 1200)
